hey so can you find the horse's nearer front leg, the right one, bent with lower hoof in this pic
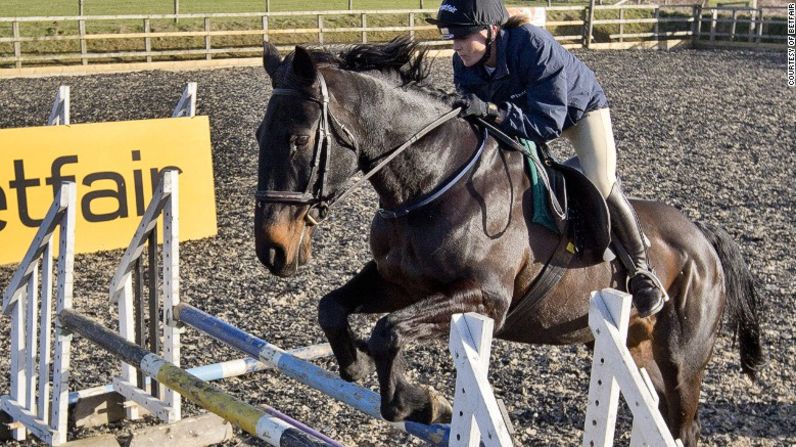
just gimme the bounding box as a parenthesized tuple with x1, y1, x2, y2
(368, 287, 509, 424)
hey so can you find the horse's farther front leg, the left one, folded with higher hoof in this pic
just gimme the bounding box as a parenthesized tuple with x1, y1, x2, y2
(318, 261, 399, 382)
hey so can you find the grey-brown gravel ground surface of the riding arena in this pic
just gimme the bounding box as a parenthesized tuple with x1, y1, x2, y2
(0, 50, 796, 447)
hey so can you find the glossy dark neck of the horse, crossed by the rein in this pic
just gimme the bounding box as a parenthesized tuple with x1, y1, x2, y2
(346, 75, 478, 208)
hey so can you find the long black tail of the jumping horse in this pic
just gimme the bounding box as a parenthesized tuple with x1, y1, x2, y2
(697, 222, 764, 380)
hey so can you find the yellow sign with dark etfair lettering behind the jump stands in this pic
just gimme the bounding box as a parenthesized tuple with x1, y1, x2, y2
(0, 116, 216, 264)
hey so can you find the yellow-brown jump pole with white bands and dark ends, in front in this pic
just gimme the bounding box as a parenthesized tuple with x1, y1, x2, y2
(58, 309, 343, 447)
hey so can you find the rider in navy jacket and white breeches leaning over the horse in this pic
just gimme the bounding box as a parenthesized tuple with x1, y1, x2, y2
(426, 0, 665, 317)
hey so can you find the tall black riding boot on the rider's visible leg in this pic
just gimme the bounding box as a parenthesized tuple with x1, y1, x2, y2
(606, 181, 666, 318)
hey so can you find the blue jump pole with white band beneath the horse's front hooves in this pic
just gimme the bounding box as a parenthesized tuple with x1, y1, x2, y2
(174, 303, 450, 446)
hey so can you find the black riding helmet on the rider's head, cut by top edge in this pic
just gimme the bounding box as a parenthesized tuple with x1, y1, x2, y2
(426, 0, 509, 39)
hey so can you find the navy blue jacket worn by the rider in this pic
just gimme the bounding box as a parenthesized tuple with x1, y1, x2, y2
(453, 24, 608, 143)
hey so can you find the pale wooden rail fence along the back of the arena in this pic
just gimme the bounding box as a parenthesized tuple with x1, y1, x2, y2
(0, 4, 787, 68)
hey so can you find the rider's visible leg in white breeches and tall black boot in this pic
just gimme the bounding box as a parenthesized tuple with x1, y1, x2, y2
(563, 108, 665, 317)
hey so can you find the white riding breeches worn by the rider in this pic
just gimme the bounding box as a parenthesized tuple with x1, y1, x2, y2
(561, 108, 616, 198)
